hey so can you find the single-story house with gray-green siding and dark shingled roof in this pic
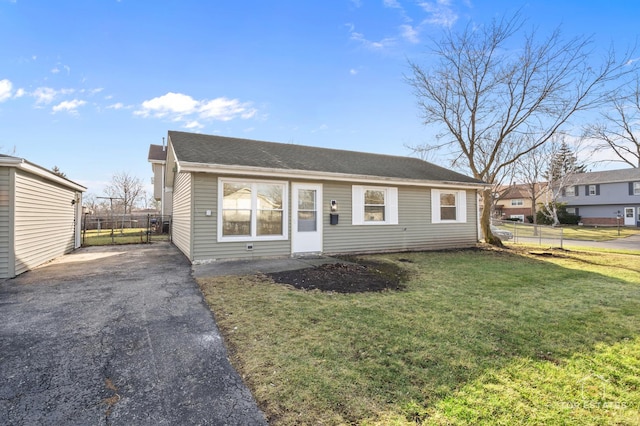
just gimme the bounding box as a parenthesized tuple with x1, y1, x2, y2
(154, 131, 487, 263)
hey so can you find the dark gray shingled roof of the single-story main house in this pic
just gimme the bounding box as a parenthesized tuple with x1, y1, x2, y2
(169, 131, 484, 184)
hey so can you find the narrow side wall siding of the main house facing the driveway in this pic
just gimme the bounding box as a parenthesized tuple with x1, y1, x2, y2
(171, 173, 194, 261)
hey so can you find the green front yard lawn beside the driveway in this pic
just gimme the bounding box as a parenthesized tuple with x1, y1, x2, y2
(199, 248, 640, 425)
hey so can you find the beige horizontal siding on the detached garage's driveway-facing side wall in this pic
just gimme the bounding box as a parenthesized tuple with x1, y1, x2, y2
(14, 170, 76, 275)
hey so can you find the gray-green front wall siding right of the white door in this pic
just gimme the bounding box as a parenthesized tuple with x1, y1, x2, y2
(323, 183, 477, 254)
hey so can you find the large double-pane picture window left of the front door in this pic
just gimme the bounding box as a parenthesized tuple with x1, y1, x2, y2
(218, 179, 287, 241)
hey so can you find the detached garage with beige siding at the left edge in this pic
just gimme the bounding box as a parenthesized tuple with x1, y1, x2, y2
(0, 155, 87, 278)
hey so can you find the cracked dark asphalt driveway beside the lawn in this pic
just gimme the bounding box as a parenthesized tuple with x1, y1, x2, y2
(0, 243, 266, 425)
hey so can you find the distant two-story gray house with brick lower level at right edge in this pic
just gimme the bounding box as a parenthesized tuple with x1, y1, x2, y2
(558, 168, 640, 226)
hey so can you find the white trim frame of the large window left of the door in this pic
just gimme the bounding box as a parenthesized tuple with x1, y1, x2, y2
(217, 178, 289, 243)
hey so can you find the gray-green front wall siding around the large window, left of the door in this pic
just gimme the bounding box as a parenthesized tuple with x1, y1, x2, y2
(190, 173, 291, 262)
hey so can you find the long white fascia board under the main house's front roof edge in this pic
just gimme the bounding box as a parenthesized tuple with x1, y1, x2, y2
(176, 161, 491, 190)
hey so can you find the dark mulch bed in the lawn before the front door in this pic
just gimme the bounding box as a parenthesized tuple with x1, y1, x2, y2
(267, 262, 406, 293)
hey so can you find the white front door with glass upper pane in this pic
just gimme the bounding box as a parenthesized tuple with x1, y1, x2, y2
(291, 183, 322, 254)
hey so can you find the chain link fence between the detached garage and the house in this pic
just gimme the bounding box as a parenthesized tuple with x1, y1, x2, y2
(82, 214, 171, 246)
